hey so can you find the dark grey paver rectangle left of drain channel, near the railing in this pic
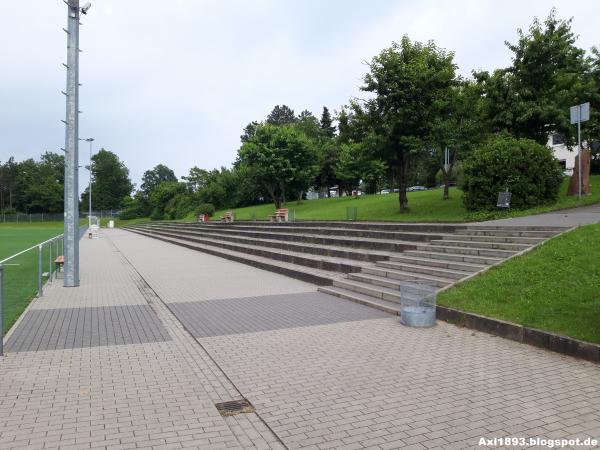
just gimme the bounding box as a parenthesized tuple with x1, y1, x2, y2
(6, 305, 171, 352)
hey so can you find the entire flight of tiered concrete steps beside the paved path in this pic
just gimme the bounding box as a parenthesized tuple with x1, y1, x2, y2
(124, 222, 564, 313)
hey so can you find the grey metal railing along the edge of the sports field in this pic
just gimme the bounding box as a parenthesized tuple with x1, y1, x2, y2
(0, 226, 87, 356)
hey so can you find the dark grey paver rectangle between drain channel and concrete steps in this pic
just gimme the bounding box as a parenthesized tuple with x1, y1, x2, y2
(168, 292, 391, 338)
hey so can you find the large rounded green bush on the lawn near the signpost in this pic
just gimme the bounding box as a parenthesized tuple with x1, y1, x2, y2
(460, 135, 562, 211)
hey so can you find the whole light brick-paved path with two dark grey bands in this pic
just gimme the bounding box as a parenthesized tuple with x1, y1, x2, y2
(0, 230, 600, 449)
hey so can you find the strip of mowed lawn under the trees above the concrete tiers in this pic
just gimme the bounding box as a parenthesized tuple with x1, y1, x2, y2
(210, 175, 600, 222)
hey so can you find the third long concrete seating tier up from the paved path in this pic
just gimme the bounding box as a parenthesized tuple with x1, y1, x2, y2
(135, 226, 391, 262)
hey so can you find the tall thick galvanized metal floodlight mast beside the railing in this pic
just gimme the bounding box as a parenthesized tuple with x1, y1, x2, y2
(64, 0, 91, 287)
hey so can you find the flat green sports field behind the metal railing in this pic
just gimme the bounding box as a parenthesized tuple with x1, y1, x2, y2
(0, 222, 63, 334)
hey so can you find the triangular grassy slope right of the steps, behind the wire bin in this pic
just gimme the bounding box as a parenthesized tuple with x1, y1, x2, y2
(438, 224, 600, 343)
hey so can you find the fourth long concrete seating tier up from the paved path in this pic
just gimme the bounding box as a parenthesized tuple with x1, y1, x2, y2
(135, 224, 417, 252)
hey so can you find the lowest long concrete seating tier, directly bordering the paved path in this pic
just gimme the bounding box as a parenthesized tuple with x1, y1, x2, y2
(125, 227, 340, 286)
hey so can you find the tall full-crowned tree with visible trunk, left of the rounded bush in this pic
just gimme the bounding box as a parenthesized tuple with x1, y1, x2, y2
(356, 36, 456, 211)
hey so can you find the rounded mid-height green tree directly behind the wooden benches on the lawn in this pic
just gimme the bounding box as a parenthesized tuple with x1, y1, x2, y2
(236, 123, 317, 208)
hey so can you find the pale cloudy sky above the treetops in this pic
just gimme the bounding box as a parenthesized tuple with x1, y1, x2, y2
(0, 0, 600, 191)
